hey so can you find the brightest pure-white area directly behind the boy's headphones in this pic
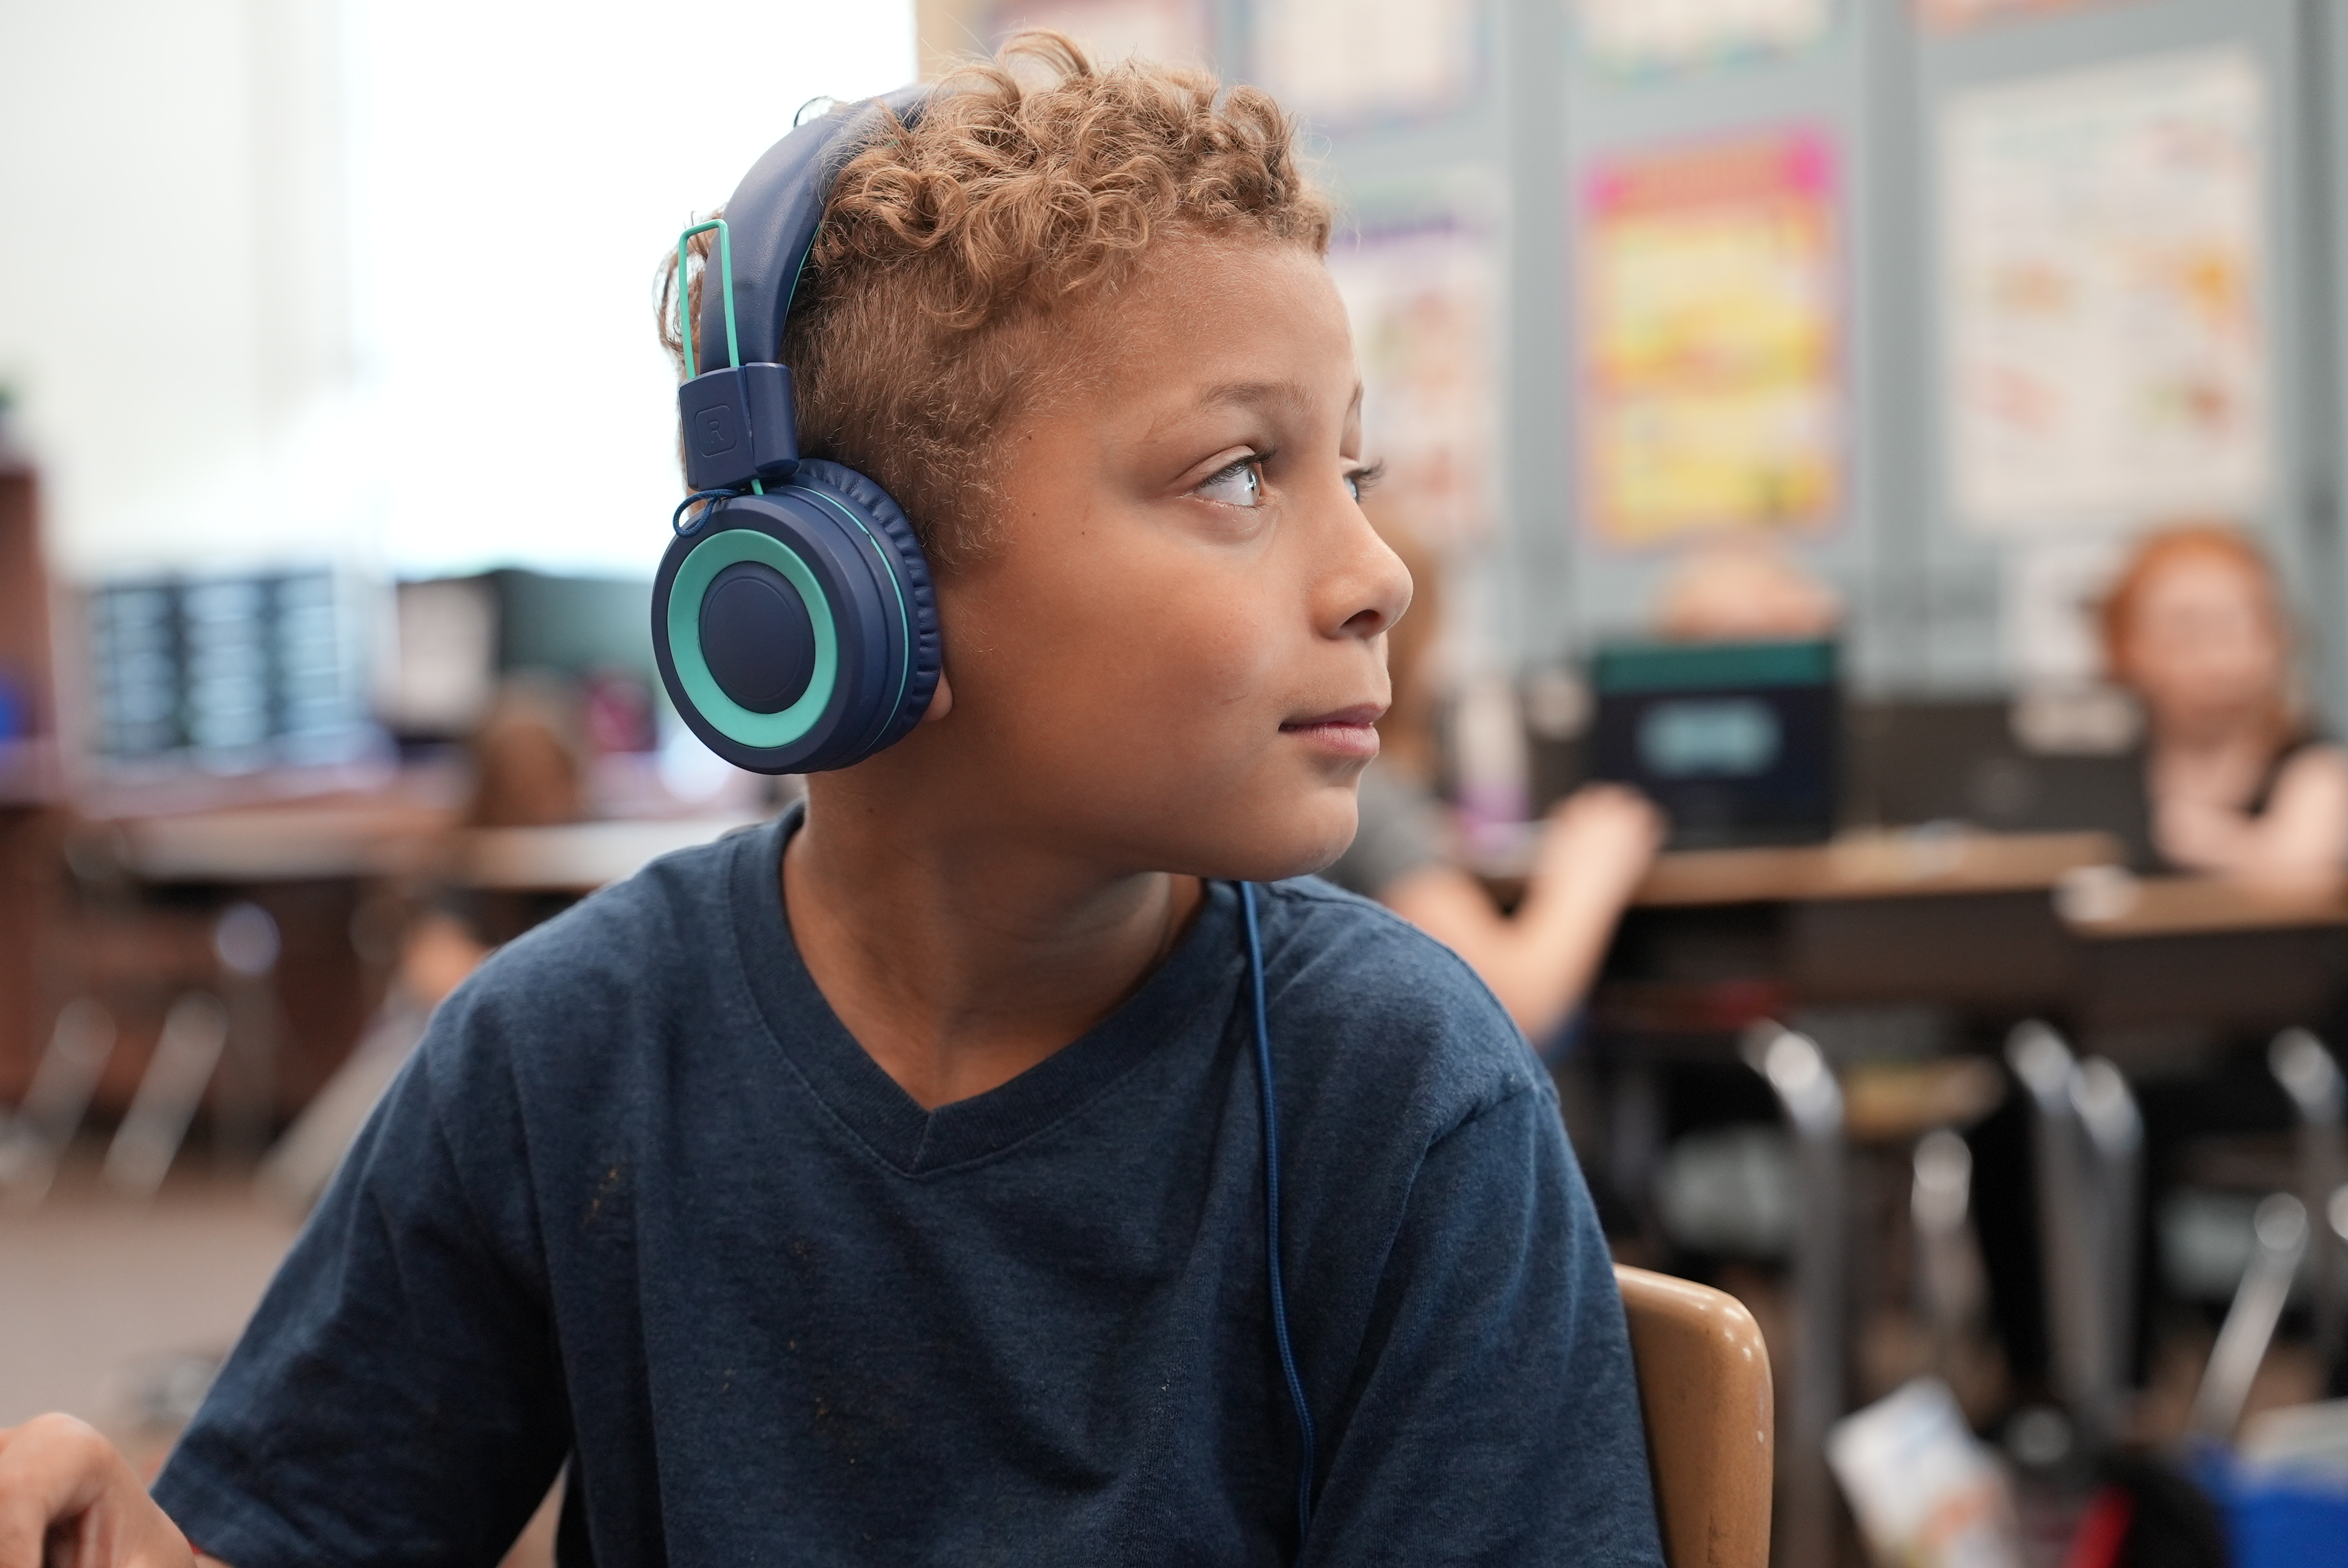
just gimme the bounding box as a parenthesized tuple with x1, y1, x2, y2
(357, 0, 913, 575)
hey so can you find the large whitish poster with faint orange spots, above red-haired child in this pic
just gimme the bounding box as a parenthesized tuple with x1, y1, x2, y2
(1939, 49, 2270, 533)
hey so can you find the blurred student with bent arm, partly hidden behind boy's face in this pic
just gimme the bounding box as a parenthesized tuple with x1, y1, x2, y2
(1322, 504, 1665, 1045)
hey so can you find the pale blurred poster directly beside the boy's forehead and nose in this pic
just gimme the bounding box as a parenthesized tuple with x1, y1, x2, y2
(1329, 195, 1505, 547)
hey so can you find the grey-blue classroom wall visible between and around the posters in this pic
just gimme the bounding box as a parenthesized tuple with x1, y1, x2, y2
(920, 0, 2348, 725)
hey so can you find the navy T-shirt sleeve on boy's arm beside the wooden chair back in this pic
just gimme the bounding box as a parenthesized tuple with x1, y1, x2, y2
(1301, 1089, 1662, 1568)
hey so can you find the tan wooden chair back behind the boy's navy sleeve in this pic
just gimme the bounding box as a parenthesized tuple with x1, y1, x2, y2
(1615, 1265, 1775, 1568)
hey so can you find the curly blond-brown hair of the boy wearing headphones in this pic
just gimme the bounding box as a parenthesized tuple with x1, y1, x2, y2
(660, 30, 1331, 568)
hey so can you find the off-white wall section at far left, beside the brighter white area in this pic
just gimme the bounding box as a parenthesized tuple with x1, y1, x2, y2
(0, 0, 350, 577)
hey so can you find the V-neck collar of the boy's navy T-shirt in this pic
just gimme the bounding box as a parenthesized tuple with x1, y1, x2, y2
(730, 805, 1240, 1176)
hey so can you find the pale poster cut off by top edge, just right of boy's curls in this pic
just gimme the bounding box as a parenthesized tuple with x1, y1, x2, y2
(1252, 0, 1484, 129)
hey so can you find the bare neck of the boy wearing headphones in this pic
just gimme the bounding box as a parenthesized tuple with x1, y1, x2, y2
(782, 765, 1202, 1110)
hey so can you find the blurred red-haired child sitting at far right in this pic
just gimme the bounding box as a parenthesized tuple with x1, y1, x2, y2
(2102, 523, 2348, 892)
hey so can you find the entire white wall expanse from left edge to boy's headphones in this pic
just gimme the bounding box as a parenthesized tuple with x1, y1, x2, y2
(0, 0, 913, 580)
